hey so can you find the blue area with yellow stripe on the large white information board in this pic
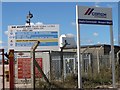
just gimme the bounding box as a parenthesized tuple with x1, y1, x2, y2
(15, 31, 58, 47)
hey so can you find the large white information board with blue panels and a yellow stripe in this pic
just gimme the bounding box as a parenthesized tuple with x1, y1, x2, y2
(8, 24, 59, 51)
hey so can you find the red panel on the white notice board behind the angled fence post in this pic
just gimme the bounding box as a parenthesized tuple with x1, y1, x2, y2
(18, 58, 42, 79)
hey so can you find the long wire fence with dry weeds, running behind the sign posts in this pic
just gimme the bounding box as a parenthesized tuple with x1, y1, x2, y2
(12, 51, 120, 88)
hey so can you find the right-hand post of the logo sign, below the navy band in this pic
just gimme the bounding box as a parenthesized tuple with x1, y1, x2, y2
(110, 25, 116, 88)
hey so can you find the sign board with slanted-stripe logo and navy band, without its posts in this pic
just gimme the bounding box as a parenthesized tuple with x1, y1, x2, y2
(78, 6, 112, 25)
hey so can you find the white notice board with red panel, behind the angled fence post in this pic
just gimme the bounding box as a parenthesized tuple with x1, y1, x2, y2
(15, 52, 50, 88)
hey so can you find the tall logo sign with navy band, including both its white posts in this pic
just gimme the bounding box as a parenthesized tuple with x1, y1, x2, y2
(76, 5, 116, 88)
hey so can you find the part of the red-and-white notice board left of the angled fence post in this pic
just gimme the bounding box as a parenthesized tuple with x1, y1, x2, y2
(15, 52, 31, 88)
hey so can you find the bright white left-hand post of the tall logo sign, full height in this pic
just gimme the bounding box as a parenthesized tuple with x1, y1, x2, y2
(76, 5, 82, 88)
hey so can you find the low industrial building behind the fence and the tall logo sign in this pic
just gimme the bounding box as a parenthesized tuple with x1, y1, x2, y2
(51, 44, 120, 77)
